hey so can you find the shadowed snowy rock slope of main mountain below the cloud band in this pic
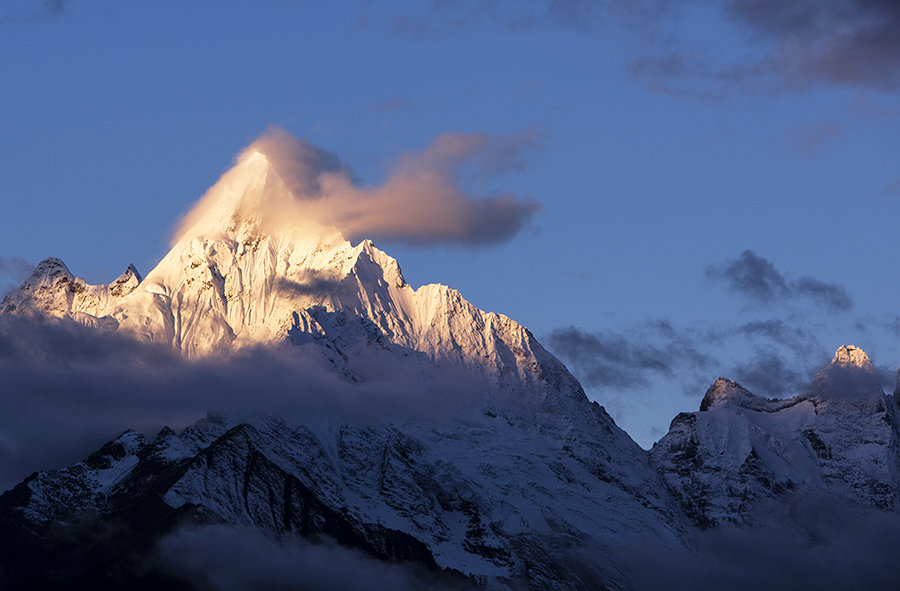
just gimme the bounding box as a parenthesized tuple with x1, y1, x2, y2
(0, 417, 680, 589)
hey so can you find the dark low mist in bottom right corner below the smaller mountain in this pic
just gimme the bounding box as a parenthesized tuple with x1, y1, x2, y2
(623, 498, 900, 591)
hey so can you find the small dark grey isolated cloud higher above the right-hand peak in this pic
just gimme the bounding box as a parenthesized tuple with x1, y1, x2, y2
(706, 250, 853, 312)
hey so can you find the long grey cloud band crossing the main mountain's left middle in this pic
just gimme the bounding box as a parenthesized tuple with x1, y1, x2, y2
(0, 318, 485, 490)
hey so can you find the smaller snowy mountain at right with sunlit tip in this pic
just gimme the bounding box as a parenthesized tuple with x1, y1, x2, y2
(650, 346, 900, 525)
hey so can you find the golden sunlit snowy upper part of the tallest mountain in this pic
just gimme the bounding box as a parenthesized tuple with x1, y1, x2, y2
(0, 136, 540, 382)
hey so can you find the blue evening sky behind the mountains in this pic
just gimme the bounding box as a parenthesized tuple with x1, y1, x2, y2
(0, 0, 900, 446)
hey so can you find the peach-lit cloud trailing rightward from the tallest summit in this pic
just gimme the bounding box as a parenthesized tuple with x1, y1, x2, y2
(174, 129, 539, 244)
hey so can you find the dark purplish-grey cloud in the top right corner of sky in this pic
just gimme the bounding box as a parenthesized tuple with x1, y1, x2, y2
(632, 0, 900, 96)
